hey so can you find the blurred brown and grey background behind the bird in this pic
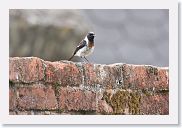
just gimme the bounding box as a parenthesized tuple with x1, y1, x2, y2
(10, 9, 169, 66)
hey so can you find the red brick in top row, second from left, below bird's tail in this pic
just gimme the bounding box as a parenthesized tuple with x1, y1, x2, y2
(44, 62, 82, 86)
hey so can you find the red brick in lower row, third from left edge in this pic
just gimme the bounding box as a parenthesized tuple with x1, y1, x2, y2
(59, 88, 96, 111)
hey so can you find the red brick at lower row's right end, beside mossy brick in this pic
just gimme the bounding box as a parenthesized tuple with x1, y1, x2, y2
(140, 94, 169, 115)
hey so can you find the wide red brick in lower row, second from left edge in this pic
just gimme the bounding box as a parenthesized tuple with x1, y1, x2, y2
(17, 85, 58, 110)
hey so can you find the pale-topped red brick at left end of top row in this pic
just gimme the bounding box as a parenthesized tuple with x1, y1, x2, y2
(9, 57, 44, 83)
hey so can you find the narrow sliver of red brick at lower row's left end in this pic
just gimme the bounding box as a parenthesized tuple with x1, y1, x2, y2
(9, 88, 17, 110)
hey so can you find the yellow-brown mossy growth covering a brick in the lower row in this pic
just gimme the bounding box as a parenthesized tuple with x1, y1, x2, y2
(103, 90, 141, 114)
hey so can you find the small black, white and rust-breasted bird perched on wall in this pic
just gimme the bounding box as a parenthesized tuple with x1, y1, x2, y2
(69, 32, 96, 62)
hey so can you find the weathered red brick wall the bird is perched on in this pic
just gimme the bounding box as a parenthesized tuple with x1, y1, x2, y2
(9, 57, 169, 115)
